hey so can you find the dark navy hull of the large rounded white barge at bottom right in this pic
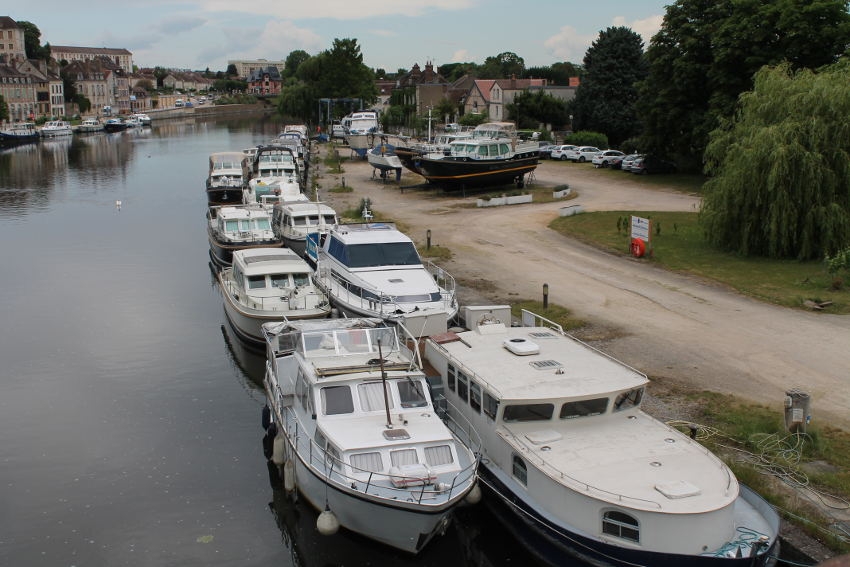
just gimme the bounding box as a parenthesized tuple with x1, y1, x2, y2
(478, 463, 779, 567)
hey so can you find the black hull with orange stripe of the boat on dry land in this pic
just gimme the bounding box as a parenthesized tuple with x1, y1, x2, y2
(414, 155, 539, 188)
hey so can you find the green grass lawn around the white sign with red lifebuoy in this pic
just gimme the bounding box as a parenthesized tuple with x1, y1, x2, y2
(550, 211, 850, 314)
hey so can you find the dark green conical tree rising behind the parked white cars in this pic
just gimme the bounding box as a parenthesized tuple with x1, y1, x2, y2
(572, 27, 647, 145)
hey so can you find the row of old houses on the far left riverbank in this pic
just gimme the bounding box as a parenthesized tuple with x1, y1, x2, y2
(0, 16, 212, 122)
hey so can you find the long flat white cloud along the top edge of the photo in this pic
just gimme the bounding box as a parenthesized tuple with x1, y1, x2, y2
(198, 0, 476, 20)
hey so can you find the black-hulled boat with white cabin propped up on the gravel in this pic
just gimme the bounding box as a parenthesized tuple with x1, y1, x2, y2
(413, 122, 540, 188)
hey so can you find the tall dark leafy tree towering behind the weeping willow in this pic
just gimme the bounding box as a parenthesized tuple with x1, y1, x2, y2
(638, 0, 850, 169)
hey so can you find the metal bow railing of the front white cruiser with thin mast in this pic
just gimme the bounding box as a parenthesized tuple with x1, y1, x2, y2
(284, 411, 479, 506)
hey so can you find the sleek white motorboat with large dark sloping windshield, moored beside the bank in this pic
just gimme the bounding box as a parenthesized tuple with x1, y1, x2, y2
(307, 222, 458, 336)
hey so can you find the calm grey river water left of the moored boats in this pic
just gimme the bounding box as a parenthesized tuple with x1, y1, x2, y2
(0, 115, 548, 567)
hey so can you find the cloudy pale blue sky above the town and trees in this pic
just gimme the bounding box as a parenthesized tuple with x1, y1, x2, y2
(6, 0, 673, 72)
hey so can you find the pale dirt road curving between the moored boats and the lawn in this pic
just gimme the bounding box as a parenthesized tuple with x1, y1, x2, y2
(319, 150, 850, 429)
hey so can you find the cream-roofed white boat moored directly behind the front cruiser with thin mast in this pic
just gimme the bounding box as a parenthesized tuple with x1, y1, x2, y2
(216, 248, 331, 344)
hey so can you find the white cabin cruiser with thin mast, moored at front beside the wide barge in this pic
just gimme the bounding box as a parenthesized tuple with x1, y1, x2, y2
(263, 318, 480, 553)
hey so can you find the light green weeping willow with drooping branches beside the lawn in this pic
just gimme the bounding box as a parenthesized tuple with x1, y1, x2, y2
(700, 60, 850, 260)
